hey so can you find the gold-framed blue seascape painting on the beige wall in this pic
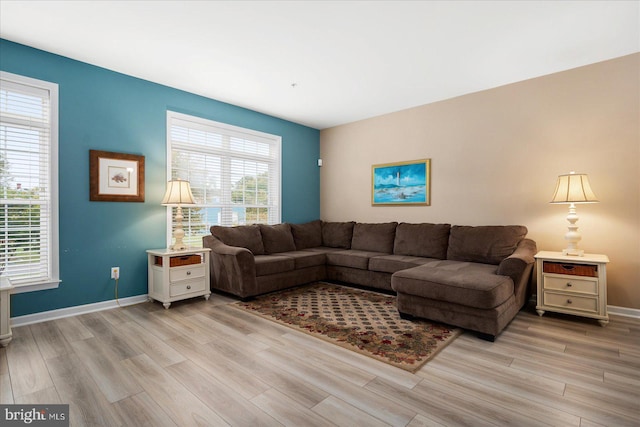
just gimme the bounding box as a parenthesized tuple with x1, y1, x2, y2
(371, 159, 431, 206)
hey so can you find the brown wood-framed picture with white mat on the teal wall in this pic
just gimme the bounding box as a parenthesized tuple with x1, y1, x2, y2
(89, 150, 144, 202)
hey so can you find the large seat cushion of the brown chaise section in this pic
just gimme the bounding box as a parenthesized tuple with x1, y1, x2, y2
(391, 261, 514, 309)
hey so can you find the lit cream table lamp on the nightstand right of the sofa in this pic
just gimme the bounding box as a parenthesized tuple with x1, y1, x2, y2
(549, 172, 598, 256)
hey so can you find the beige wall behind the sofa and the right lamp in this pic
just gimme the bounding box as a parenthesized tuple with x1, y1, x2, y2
(320, 54, 640, 309)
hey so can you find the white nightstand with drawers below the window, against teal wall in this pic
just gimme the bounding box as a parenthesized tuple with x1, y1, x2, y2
(147, 248, 211, 308)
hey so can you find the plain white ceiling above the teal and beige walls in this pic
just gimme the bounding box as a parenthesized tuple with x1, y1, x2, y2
(0, 0, 640, 129)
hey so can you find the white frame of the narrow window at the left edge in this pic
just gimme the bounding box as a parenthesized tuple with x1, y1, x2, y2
(0, 71, 60, 294)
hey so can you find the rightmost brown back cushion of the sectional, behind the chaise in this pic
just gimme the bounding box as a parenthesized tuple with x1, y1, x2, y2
(447, 225, 527, 265)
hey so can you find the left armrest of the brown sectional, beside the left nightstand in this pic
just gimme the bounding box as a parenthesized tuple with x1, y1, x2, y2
(202, 235, 257, 298)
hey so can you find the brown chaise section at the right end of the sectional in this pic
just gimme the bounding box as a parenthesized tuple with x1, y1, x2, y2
(391, 226, 536, 341)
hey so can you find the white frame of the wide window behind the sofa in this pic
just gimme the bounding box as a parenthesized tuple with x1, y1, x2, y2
(167, 110, 282, 247)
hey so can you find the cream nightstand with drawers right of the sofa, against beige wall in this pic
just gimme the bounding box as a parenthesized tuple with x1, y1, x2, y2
(536, 251, 609, 326)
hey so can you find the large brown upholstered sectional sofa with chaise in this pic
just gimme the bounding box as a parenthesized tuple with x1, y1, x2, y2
(203, 220, 536, 340)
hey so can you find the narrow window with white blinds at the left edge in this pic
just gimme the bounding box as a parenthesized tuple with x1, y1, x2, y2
(0, 72, 59, 292)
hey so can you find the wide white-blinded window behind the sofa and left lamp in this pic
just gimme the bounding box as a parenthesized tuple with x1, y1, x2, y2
(167, 111, 282, 247)
